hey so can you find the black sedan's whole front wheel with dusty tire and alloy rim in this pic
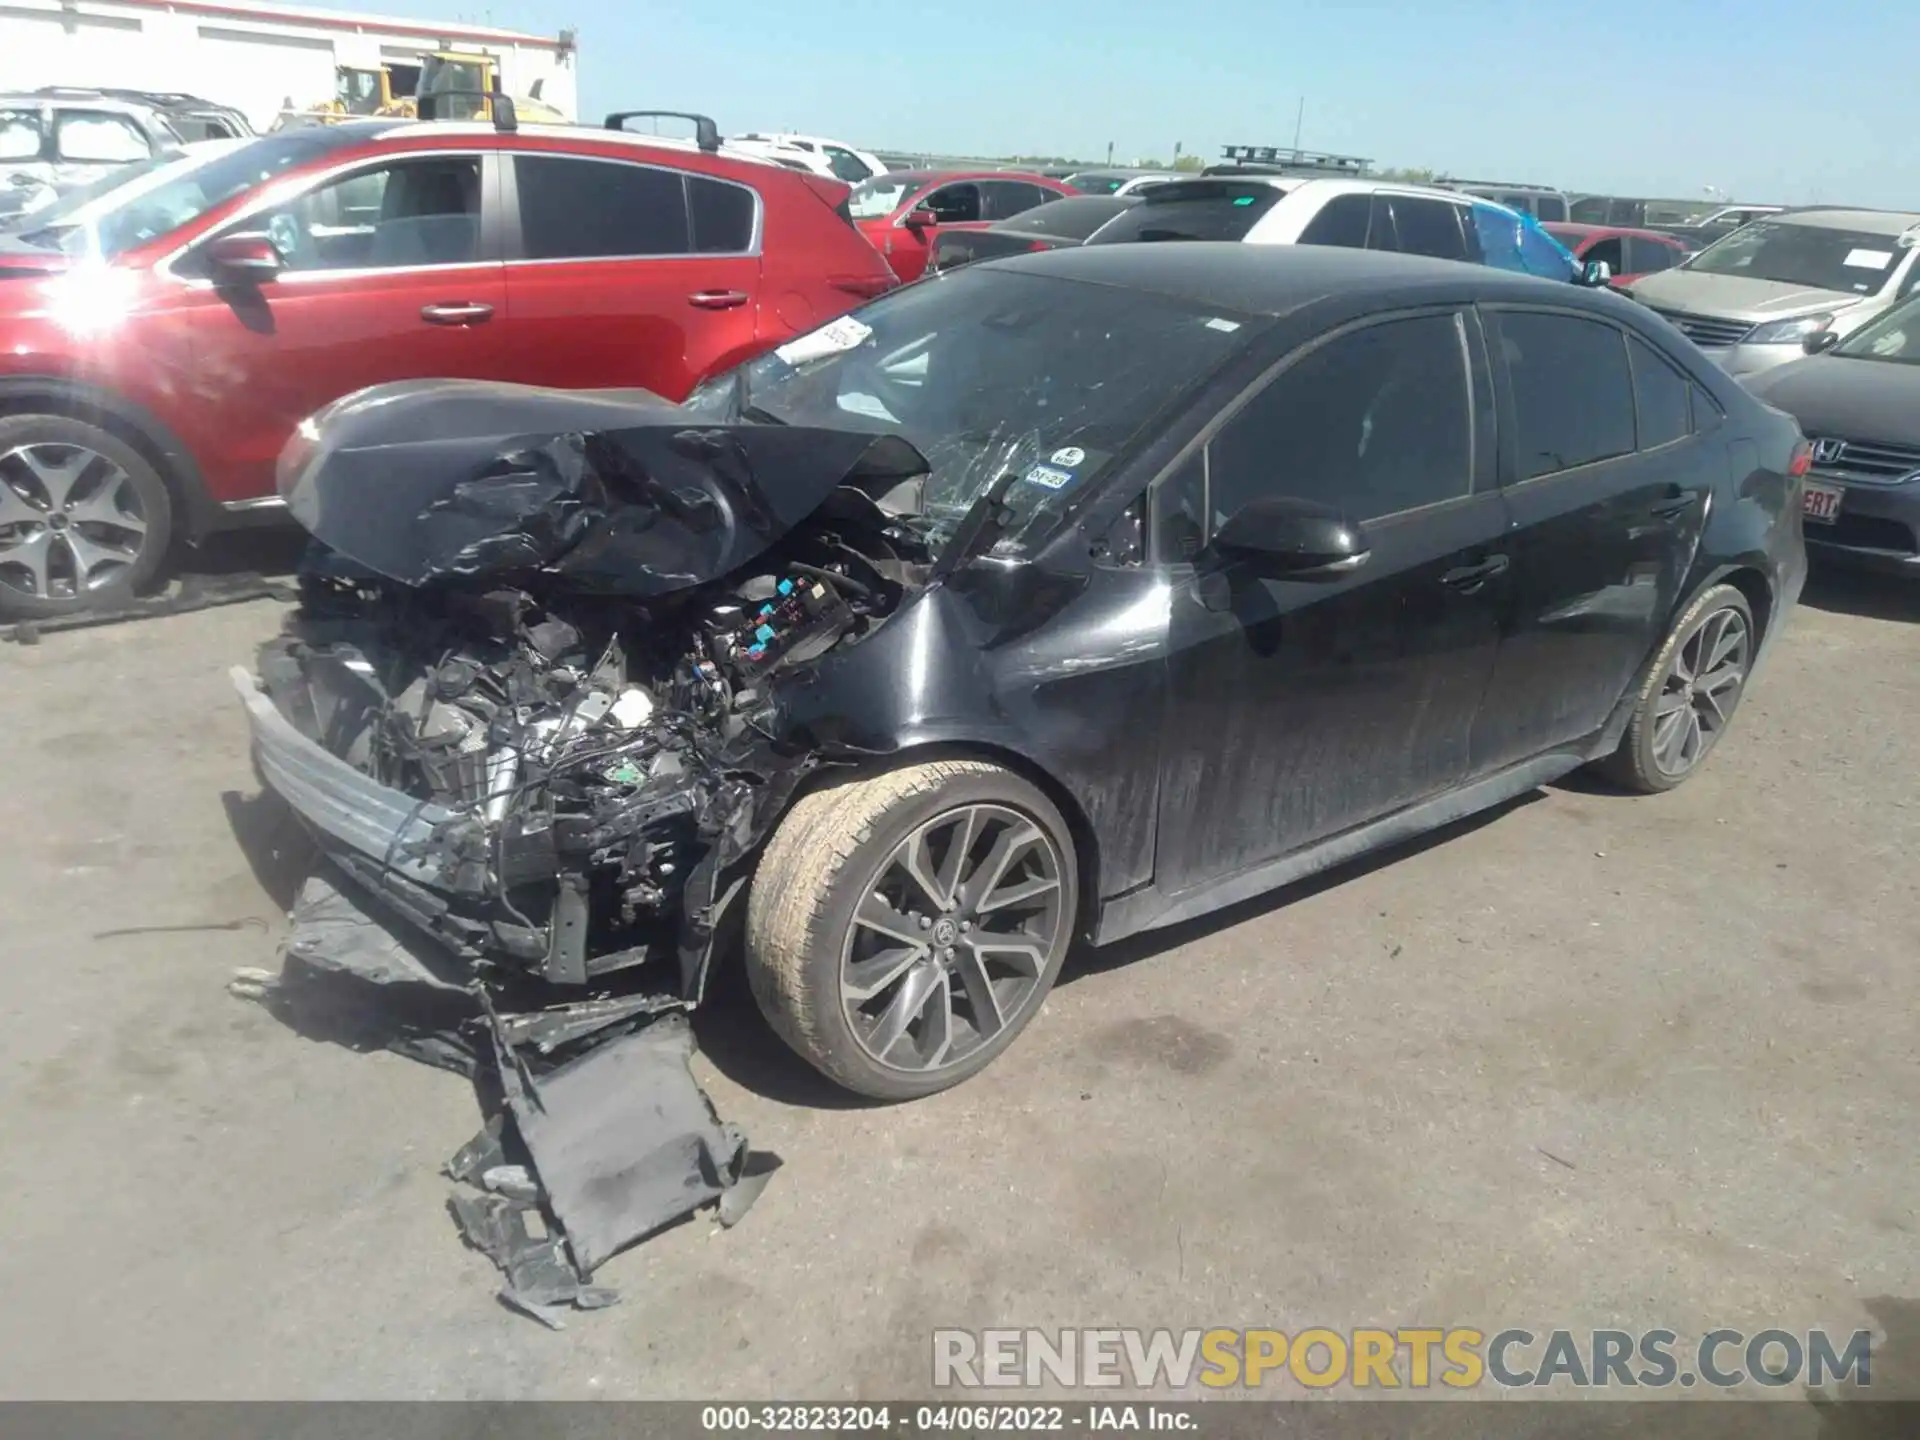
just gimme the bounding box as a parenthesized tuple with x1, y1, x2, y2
(747, 760, 1079, 1100)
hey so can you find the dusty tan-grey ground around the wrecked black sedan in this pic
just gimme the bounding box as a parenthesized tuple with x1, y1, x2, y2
(0, 580, 1920, 1398)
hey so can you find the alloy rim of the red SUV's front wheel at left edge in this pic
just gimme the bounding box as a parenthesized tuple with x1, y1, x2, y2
(0, 442, 146, 599)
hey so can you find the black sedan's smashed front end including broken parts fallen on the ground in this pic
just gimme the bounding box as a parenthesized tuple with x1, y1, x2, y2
(234, 382, 929, 1325)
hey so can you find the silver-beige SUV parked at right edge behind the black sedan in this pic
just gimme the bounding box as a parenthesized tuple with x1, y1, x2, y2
(1628, 207, 1920, 374)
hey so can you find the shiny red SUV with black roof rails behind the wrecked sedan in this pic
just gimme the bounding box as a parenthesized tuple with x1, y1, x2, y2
(0, 107, 895, 618)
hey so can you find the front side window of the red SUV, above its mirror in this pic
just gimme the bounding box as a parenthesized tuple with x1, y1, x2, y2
(238, 156, 480, 271)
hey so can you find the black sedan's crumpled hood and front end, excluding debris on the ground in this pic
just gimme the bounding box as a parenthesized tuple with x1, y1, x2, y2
(234, 382, 927, 1002)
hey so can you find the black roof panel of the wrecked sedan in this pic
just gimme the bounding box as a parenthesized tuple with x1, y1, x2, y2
(979, 240, 1605, 315)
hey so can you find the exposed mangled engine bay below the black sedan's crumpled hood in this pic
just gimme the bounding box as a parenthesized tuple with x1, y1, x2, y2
(259, 491, 927, 998)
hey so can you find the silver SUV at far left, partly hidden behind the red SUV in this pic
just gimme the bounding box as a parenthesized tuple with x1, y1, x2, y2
(0, 92, 180, 225)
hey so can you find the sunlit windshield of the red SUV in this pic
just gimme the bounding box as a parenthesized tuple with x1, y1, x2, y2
(19, 127, 357, 259)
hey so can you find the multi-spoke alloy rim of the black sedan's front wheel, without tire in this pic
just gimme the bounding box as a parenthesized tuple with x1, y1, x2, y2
(839, 804, 1069, 1075)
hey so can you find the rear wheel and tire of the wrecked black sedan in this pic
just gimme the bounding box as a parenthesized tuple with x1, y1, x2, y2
(1599, 586, 1759, 795)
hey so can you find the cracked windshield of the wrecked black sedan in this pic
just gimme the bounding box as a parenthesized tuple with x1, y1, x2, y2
(687, 271, 1261, 553)
